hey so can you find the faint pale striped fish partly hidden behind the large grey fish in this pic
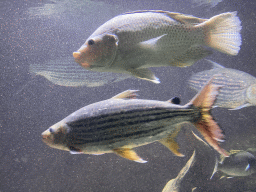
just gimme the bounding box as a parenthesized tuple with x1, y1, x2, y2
(29, 56, 132, 87)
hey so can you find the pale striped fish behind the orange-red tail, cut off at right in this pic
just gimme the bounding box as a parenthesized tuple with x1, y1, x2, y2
(188, 60, 256, 110)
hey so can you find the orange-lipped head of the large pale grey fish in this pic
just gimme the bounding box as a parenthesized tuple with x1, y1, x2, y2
(73, 34, 118, 70)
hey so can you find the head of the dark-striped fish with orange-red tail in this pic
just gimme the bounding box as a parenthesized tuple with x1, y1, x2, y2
(42, 122, 69, 151)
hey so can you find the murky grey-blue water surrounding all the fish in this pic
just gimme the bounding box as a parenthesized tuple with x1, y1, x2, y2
(0, 0, 256, 192)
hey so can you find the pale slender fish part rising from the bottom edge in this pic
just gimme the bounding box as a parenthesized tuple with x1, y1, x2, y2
(162, 151, 196, 192)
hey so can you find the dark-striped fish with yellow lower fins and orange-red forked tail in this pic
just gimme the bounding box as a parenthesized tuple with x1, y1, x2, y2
(42, 78, 227, 163)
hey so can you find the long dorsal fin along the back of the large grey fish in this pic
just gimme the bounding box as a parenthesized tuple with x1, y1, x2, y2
(124, 10, 208, 25)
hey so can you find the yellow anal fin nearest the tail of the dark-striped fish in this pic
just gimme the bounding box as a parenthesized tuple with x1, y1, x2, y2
(159, 127, 184, 157)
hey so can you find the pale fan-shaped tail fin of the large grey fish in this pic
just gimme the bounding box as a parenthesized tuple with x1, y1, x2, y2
(199, 12, 242, 55)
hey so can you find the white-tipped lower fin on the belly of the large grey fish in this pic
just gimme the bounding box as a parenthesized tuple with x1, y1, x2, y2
(127, 68, 160, 84)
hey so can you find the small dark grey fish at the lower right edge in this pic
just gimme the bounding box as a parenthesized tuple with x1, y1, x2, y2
(211, 150, 256, 178)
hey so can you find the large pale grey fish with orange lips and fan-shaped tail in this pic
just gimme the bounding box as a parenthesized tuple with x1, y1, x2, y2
(73, 10, 242, 83)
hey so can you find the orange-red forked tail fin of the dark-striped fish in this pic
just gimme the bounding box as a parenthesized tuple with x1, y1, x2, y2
(188, 77, 228, 156)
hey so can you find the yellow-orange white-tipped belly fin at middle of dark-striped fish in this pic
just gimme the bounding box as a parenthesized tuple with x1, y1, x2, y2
(113, 148, 147, 163)
